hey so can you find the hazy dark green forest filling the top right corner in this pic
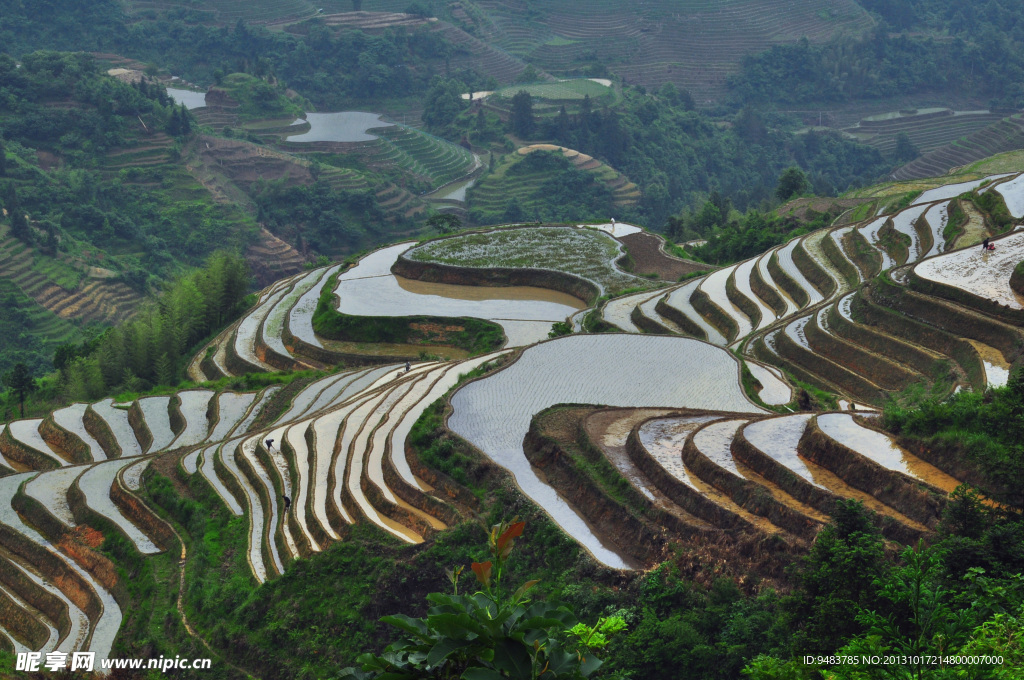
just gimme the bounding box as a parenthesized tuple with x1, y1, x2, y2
(730, 0, 1024, 110)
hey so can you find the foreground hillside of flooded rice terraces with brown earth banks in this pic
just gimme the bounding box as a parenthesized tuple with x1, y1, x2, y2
(0, 174, 1024, 656)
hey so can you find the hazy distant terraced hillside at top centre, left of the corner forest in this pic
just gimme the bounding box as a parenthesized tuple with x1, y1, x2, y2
(460, 0, 872, 102)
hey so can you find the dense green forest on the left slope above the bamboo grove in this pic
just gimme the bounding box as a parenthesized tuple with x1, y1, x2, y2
(0, 52, 253, 278)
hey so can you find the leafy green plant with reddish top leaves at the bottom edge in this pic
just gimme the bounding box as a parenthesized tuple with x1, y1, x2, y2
(340, 521, 626, 680)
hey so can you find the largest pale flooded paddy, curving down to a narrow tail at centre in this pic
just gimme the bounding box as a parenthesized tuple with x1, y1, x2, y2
(449, 335, 761, 568)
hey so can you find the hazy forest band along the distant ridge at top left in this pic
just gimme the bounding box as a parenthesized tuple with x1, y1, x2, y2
(0, 0, 486, 110)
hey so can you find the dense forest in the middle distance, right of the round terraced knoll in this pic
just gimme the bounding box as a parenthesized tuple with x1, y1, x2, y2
(436, 83, 895, 229)
